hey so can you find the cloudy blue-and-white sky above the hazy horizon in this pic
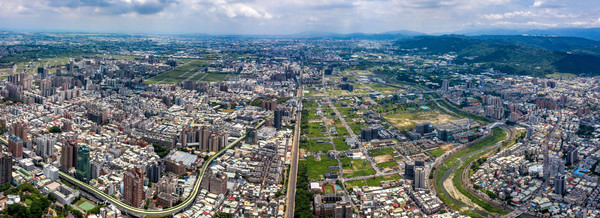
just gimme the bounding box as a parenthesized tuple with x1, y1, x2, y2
(0, 0, 600, 34)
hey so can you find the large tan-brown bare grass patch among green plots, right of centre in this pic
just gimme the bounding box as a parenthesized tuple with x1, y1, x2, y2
(384, 110, 458, 130)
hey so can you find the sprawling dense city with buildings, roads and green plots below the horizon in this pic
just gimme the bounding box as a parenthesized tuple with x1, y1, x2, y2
(0, 28, 600, 218)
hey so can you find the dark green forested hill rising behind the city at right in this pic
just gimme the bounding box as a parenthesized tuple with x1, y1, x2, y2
(395, 35, 600, 76)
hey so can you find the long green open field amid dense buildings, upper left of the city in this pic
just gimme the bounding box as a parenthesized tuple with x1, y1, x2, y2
(146, 60, 211, 84)
